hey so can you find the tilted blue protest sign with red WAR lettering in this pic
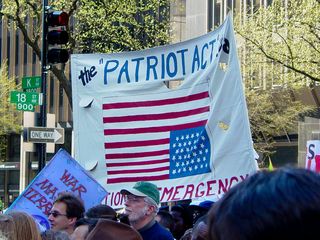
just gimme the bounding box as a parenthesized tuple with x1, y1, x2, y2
(7, 149, 107, 229)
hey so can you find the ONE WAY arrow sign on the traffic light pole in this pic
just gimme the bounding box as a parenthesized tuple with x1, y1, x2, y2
(24, 127, 64, 144)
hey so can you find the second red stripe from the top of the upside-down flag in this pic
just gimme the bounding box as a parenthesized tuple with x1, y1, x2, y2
(103, 106, 210, 123)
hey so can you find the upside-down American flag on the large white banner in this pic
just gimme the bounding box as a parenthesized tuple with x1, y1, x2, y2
(103, 83, 211, 184)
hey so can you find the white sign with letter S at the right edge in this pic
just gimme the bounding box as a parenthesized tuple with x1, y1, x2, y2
(306, 140, 320, 172)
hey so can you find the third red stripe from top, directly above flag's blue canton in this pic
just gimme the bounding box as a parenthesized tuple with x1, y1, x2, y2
(104, 120, 207, 135)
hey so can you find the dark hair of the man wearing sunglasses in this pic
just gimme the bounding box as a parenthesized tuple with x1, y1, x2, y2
(54, 193, 85, 220)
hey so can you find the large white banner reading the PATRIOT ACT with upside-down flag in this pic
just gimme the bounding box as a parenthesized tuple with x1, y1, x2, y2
(71, 17, 256, 207)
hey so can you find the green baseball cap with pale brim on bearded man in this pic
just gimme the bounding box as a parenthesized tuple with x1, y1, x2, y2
(120, 182, 160, 204)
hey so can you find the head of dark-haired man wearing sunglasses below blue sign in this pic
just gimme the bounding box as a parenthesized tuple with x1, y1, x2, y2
(48, 193, 85, 235)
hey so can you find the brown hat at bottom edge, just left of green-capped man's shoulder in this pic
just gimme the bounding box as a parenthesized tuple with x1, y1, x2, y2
(85, 219, 142, 240)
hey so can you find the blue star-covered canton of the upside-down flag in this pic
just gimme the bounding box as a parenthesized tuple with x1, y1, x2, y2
(169, 127, 211, 179)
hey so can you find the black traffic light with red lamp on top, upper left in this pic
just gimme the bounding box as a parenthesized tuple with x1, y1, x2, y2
(46, 11, 69, 64)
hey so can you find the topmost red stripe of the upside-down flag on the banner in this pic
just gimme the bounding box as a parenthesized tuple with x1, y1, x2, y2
(103, 92, 209, 110)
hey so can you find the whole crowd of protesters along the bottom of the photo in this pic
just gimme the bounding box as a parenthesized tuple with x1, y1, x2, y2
(0, 168, 320, 240)
